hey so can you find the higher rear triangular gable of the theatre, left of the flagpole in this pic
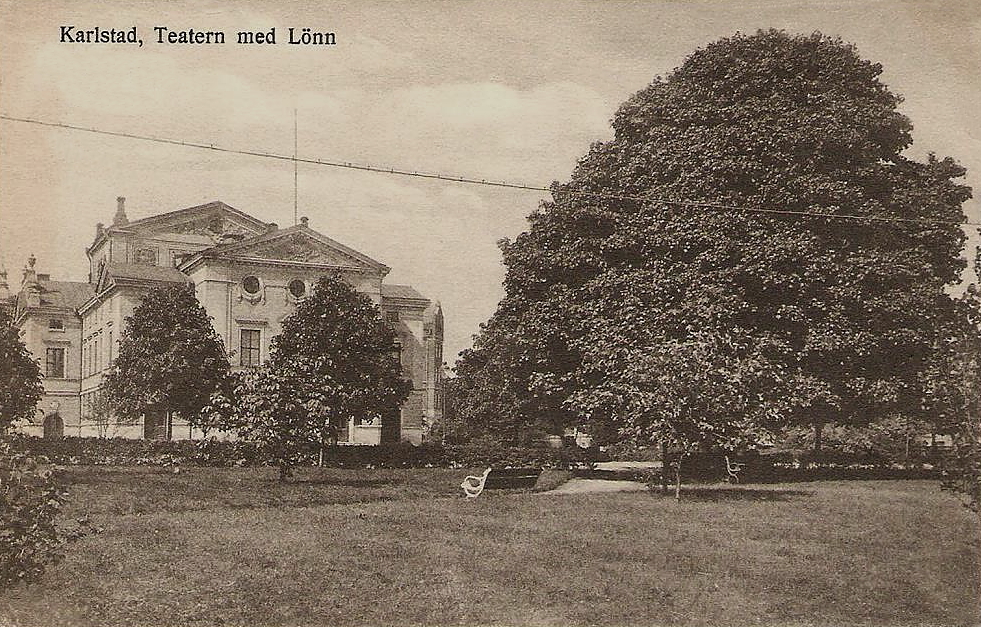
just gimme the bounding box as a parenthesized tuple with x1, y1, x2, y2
(124, 201, 270, 241)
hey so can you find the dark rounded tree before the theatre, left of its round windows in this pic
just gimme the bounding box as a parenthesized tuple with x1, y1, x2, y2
(105, 285, 229, 424)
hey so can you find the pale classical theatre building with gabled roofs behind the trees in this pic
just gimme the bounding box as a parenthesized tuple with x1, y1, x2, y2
(0, 198, 443, 444)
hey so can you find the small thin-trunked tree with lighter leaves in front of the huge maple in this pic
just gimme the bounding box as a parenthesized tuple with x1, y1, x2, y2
(570, 331, 794, 498)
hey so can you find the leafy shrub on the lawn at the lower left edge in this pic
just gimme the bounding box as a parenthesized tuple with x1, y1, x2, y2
(0, 442, 67, 590)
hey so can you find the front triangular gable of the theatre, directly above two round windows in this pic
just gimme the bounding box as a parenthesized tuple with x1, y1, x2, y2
(200, 225, 389, 274)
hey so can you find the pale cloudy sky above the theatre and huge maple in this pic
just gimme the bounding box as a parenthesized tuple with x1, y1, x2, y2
(0, 0, 981, 365)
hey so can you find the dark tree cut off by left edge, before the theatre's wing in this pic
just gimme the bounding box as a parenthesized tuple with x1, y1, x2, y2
(0, 307, 44, 434)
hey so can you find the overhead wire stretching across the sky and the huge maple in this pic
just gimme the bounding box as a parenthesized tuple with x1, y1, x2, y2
(0, 114, 981, 227)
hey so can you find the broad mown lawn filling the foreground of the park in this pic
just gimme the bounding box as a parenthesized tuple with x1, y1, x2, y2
(0, 468, 981, 626)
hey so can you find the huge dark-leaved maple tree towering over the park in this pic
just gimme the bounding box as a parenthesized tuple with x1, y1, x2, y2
(457, 31, 970, 454)
